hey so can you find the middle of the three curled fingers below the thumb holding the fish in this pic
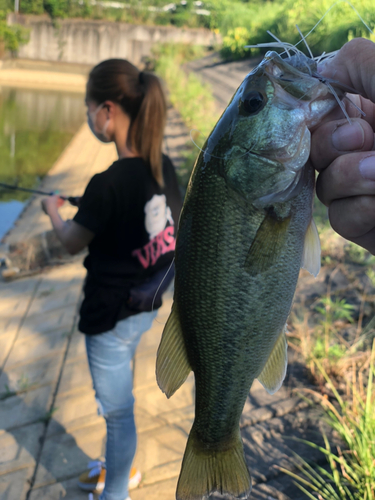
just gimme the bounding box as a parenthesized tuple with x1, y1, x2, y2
(316, 152, 375, 206)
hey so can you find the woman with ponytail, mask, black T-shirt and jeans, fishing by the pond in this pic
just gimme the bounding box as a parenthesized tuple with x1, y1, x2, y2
(42, 59, 181, 500)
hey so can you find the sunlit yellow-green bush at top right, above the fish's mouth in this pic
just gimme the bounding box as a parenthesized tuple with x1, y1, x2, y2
(216, 0, 375, 58)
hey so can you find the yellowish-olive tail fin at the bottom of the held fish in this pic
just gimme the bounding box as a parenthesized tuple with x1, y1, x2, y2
(176, 426, 251, 500)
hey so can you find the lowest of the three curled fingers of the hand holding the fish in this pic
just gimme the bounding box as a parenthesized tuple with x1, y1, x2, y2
(328, 196, 375, 253)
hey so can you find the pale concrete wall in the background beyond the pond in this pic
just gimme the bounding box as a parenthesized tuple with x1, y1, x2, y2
(8, 14, 217, 64)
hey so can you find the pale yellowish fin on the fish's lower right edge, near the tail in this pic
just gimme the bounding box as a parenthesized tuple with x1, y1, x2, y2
(258, 326, 288, 394)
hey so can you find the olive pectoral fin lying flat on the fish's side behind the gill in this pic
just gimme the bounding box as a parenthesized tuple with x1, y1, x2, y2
(245, 209, 290, 276)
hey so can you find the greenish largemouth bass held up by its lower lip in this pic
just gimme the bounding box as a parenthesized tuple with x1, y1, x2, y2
(156, 52, 344, 500)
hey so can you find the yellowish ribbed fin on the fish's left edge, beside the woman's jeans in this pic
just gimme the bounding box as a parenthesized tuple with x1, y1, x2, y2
(156, 307, 191, 398)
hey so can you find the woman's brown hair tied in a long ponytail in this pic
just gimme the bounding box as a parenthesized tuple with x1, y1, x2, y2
(87, 59, 167, 186)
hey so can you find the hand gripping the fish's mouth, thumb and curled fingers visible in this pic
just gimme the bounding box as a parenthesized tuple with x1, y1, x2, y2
(310, 39, 375, 254)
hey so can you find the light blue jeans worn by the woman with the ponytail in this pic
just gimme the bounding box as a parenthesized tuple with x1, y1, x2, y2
(86, 311, 157, 500)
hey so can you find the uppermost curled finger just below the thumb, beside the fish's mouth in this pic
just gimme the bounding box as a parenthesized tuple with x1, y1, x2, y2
(310, 118, 374, 171)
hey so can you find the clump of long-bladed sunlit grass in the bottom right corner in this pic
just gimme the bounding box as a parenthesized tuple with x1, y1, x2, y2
(279, 343, 375, 500)
